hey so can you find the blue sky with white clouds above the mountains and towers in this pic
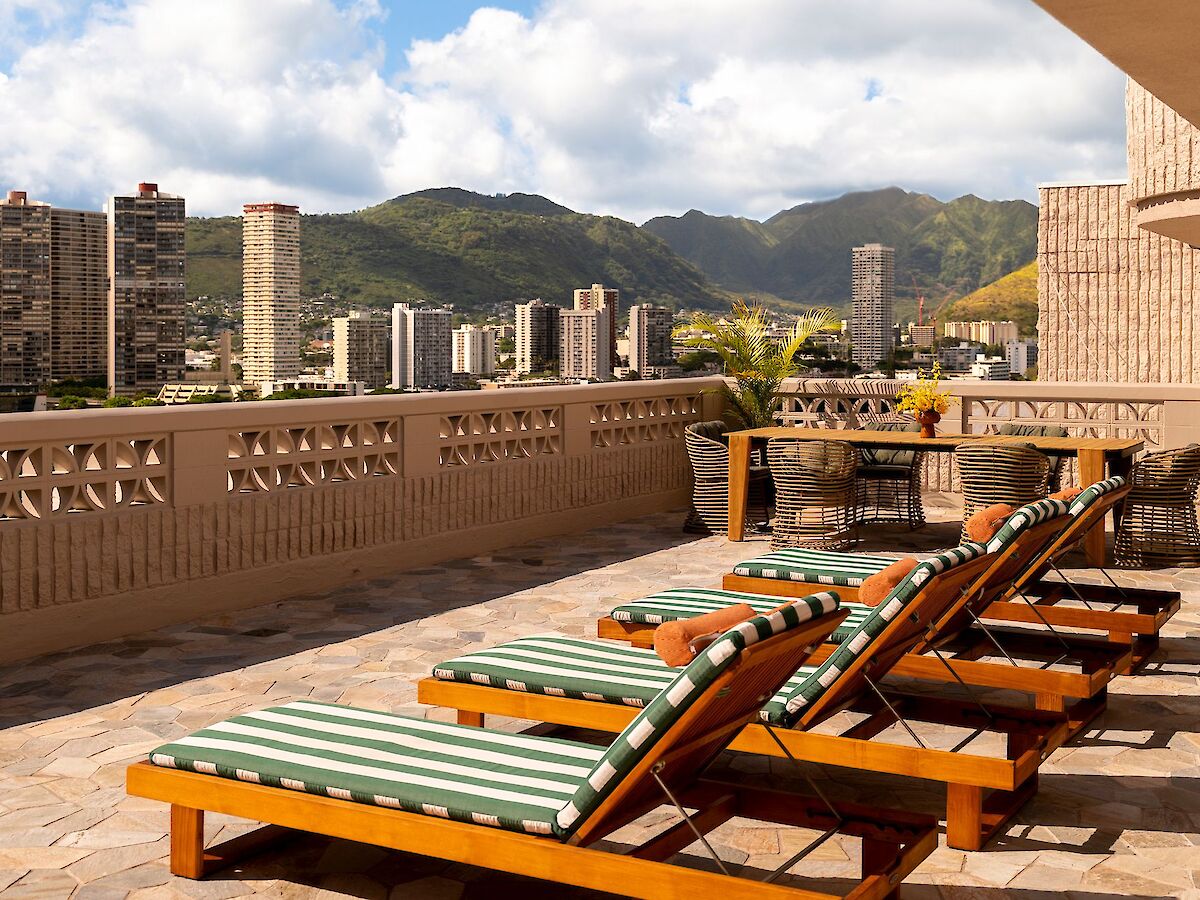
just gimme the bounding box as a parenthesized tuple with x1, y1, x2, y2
(0, 0, 1126, 222)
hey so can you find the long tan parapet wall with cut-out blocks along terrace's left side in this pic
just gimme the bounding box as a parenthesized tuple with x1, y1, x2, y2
(0, 378, 720, 660)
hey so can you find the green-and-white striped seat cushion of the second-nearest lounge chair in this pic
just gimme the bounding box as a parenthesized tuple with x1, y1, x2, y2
(433, 638, 820, 722)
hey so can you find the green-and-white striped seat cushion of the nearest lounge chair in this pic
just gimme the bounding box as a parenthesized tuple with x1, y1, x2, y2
(150, 701, 605, 834)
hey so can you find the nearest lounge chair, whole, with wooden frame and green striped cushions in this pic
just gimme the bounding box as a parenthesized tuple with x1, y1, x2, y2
(127, 601, 937, 900)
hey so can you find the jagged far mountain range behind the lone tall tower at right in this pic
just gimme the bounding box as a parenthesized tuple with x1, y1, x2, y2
(643, 187, 1037, 316)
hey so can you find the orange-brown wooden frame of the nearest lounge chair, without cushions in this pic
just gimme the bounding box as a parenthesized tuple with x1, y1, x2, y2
(126, 613, 937, 900)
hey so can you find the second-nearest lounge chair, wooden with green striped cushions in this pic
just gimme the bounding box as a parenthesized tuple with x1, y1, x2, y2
(418, 545, 1067, 850)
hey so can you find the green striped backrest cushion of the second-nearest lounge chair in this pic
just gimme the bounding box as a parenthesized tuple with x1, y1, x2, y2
(782, 544, 985, 726)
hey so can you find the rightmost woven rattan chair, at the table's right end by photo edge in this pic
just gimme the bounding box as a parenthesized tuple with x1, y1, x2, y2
(1116, 444, 1200, 569)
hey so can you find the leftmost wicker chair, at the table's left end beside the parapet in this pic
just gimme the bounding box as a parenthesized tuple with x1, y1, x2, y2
(683, 421, 772, 534)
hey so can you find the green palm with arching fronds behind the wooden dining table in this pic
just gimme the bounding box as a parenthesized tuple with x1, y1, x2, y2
(674, 299, 839, 428)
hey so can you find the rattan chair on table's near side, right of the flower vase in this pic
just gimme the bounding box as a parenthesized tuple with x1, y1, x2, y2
(954, 440, 1050, 541)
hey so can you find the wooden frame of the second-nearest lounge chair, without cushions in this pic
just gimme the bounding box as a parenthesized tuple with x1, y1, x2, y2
(416, 556, 1068, 850)
